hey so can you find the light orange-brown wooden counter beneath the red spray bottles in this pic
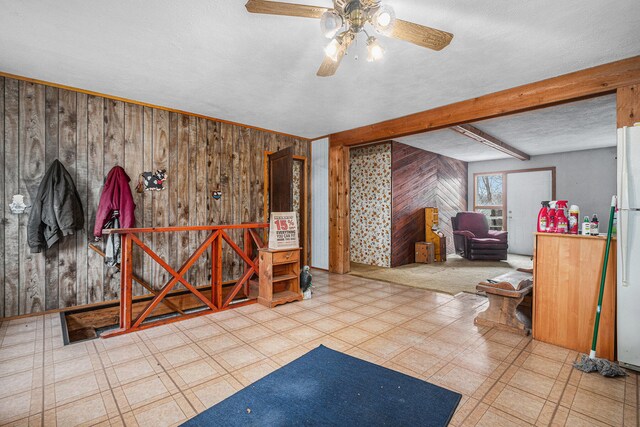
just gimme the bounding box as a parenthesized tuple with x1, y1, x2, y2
(533, 233, 616, 360)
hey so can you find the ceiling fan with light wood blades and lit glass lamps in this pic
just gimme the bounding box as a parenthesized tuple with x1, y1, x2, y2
(245, 0, 453, 77)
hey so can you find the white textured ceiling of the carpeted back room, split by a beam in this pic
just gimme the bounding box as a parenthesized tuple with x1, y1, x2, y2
(397, 95, 616, 164)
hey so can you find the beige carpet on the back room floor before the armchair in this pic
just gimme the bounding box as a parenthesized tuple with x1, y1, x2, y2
(349, 255, 533, 295)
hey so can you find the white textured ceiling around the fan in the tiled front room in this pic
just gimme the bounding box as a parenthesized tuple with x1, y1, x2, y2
(0, 0, 640, 137)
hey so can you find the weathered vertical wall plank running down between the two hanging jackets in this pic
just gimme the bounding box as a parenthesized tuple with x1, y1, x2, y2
(84, 96, 105, 303)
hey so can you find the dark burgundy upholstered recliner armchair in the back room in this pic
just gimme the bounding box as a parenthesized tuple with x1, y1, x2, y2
(451, 212, 509, 261)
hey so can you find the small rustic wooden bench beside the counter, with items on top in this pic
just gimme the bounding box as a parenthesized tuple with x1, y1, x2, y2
(474, 269, 533, 335)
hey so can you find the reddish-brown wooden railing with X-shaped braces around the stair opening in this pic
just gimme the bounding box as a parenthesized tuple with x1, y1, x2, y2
(102, 223, 268, 338)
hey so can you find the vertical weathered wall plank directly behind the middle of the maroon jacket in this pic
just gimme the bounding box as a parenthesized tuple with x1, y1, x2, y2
(102, 99, 124, 300)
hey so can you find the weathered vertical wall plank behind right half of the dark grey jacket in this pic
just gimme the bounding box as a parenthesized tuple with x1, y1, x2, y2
(58, 89, 78, 307)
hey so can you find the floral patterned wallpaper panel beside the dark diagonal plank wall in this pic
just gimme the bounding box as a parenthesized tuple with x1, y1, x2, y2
(350, 143, 391, 267)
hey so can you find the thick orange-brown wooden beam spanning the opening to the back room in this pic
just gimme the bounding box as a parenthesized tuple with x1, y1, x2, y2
(329, 56, 640, 146)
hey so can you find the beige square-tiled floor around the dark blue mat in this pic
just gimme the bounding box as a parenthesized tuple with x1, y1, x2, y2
(0, 271, 639, 427)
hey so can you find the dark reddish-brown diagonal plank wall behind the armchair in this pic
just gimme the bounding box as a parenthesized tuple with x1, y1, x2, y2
(391, 141, 467, 267)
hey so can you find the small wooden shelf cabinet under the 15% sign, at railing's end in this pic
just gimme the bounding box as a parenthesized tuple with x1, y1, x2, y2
(258, 249, 302, 307)
